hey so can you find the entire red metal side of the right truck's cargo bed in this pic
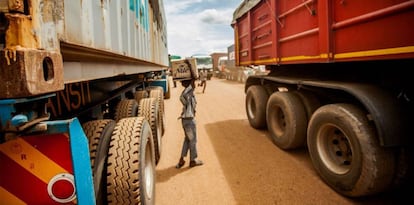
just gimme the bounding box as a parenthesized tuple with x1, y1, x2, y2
(235, 0, 414, 65)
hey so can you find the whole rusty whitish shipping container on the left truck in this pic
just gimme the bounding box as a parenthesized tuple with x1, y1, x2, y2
(0, 0, 169, 98)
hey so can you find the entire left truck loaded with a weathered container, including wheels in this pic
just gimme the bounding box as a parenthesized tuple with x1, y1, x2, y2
(0, 0, 168, 204)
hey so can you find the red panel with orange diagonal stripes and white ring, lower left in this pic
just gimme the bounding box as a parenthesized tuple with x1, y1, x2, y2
(0, 134, 76, 204)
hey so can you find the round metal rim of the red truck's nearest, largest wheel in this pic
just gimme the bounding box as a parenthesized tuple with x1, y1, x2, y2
(316, 124, 352, 174)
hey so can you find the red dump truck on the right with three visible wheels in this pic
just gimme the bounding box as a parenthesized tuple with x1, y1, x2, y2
(231, 0, 414, 198)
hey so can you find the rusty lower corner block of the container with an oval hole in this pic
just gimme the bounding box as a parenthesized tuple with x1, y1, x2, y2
(0, 49, 64, 98)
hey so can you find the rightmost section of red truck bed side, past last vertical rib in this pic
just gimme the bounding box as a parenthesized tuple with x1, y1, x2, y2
(332, 0, 414, 60)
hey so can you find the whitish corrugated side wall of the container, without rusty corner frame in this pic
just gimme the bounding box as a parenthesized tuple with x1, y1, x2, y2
(59, 0, 168, 65)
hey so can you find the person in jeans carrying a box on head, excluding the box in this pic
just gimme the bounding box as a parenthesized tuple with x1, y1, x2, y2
(175, 78, 203, 169)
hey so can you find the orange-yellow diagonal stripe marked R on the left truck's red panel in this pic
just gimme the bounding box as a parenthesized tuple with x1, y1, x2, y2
(0, 138, 68, 184)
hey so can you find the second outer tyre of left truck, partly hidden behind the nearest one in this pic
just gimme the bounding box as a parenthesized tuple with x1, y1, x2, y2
(138, 98, 162, 164)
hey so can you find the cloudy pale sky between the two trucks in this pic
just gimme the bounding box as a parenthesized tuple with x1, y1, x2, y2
(164, 0, 243, 57)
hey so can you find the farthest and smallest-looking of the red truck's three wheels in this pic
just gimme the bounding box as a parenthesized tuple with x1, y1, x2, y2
(246, 85, 269, 129)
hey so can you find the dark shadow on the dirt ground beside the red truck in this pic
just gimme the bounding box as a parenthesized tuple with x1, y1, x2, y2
(205, 120, 414, 204)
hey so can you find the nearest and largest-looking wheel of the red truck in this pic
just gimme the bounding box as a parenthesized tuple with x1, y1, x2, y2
(308, 104, 396, 197)
